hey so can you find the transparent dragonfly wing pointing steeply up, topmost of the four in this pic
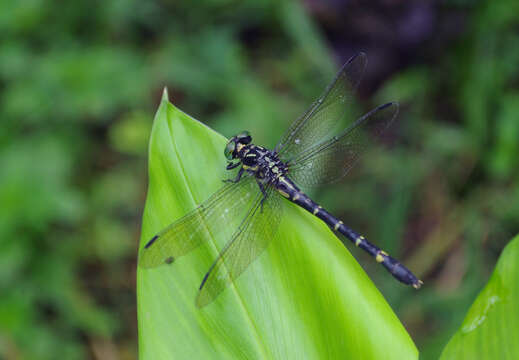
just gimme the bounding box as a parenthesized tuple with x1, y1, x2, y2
(275, 53, 367, 161)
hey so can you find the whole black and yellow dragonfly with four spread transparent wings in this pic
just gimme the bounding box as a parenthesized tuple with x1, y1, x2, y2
(139, 53, 423, 308)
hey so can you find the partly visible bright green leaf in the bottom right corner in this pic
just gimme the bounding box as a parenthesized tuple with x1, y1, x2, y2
(441, 236, 519, 360)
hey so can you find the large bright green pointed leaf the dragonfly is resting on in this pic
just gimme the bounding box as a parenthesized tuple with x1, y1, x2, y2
(137, 88, 418, 359)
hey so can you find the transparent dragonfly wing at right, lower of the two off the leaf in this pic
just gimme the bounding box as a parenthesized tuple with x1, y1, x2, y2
(288, 103, 398, 187)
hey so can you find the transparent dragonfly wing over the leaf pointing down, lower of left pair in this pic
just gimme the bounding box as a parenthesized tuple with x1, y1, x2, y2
(196, 187, 283, 307)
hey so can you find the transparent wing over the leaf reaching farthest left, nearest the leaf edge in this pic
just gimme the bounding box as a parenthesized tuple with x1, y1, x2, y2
(139, 176, 260, 268)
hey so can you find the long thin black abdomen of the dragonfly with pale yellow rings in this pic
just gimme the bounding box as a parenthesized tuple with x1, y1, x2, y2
(277, 177, 422, 289)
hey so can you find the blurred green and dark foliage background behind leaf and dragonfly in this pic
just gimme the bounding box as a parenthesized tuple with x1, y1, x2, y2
(0, 0, 519, 359)
